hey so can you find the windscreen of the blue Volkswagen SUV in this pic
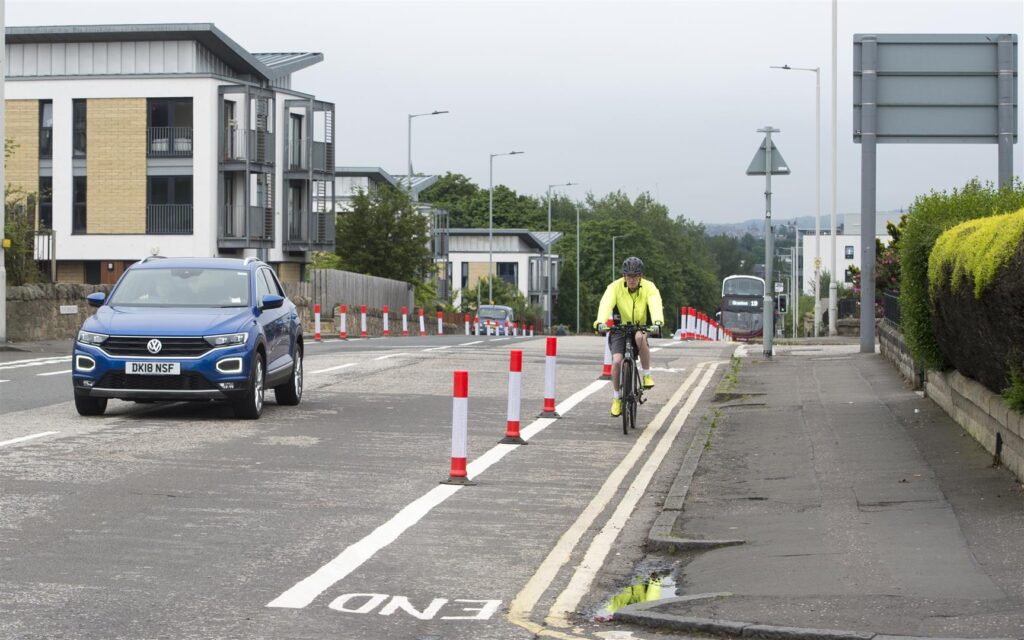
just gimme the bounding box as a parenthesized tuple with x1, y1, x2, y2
(110, 268, 249, 307)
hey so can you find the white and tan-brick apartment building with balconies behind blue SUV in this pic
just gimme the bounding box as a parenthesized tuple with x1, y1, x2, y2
(5, 24, 335, 284)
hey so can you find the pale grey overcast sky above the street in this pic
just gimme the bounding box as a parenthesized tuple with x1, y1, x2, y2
(6, 0, 1024, 222)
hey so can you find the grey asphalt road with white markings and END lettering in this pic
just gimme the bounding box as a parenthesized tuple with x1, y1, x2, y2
(0, 336, 731, 640)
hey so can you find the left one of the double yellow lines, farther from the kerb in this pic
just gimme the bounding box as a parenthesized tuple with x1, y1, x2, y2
(508, 362, 705, 620)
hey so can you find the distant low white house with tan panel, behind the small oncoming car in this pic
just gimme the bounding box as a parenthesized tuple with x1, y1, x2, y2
(447, 228, 562, 309)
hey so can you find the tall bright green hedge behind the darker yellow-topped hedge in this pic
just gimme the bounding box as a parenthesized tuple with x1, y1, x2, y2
(899, 178, 1024, 370)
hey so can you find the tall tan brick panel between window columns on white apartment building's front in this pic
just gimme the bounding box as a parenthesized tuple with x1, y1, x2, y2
(86, 98, 146, 233)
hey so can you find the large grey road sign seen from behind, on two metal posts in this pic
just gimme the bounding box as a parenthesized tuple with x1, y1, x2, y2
(851, 34, 1017, 353)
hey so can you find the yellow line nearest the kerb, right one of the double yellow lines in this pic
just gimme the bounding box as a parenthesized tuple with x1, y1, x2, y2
(546, 362, 721, 627)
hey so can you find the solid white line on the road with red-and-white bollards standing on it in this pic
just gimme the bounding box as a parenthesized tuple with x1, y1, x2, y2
(267, 380, 607, 609)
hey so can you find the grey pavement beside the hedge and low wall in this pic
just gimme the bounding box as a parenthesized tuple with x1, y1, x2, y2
(615, 343, 1024, 638)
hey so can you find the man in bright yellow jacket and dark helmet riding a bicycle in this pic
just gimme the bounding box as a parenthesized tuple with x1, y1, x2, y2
(594, 256, 665, 416)
